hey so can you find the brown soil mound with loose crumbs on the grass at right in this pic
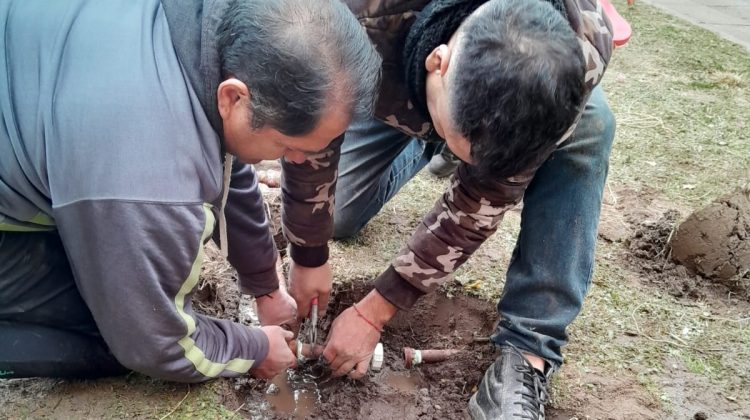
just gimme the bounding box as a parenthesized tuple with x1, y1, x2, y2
(626, 191, 750, 300)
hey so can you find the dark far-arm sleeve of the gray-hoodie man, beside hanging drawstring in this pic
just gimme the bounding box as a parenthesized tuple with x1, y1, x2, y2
(214, 159, 279, 296)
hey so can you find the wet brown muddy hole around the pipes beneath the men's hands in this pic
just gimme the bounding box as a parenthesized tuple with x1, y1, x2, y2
(222, 281, 497, 419)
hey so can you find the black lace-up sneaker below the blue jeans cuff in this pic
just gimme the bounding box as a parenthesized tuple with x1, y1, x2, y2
(469, 346, 552, 420)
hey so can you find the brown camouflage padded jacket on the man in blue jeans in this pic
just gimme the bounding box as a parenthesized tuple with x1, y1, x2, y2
(283, 0, 613, 309)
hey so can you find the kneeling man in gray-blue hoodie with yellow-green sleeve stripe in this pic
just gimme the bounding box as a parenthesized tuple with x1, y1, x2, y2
(0, 0, 380, 382)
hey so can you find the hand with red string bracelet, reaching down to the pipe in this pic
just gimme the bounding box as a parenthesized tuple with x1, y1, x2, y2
(323, 290, 398, 379)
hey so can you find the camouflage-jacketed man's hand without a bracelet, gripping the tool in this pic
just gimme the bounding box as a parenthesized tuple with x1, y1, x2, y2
(289, 261, 333, 319)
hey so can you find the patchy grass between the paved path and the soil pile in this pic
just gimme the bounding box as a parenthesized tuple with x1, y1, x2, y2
(604, 1, 750, 207)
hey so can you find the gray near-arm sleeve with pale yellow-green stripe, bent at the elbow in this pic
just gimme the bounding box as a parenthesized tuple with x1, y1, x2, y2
(55, 200, 268, 382)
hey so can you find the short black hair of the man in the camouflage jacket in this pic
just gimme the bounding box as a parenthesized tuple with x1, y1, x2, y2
(449, 0, 587, 179)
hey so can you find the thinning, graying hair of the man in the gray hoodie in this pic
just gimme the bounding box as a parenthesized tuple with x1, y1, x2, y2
(218, 0, 380, 136)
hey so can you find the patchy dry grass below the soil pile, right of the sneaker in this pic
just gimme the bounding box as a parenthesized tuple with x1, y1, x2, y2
(566, 244, 750, 408)
